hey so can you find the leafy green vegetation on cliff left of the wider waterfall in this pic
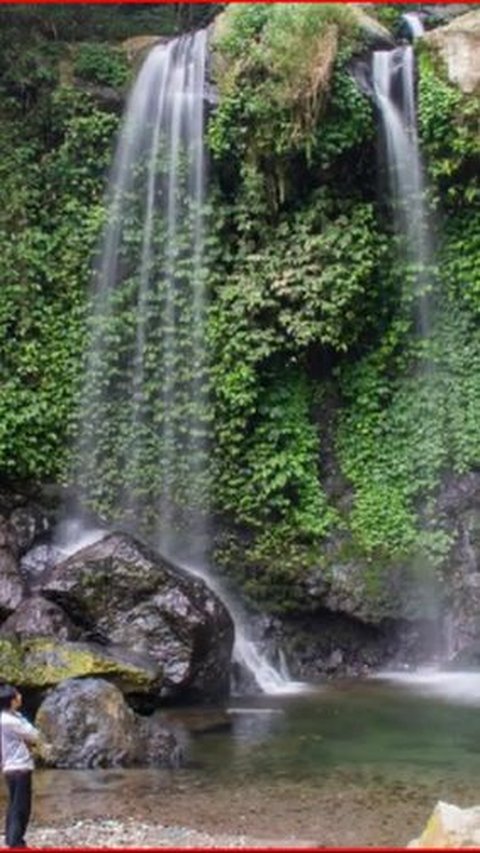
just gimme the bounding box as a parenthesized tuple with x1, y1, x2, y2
(0, 80, 118, 480)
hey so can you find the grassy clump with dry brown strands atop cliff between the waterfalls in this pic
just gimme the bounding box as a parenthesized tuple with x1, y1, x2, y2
(210, 3, 375, 165)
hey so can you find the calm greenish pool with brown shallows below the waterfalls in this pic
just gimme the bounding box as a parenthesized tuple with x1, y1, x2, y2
(15, 673, 480, 846)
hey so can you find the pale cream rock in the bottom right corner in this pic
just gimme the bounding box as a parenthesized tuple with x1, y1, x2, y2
(408, 801, 480, 849)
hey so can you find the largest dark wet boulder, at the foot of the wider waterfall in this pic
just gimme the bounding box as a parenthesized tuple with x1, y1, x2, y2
(41, 533, 234, 699)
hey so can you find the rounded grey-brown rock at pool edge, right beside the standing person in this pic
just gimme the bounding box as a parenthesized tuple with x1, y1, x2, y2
(35, 678, 178, 768)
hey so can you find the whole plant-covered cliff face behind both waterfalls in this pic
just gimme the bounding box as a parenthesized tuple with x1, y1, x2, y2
(0, 4, 480, 677)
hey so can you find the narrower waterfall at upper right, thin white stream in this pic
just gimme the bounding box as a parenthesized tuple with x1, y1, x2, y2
(372, 45, 432, 337)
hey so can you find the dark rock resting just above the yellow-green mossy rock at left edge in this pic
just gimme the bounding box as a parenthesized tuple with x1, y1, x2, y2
(0, 595, 79, 640)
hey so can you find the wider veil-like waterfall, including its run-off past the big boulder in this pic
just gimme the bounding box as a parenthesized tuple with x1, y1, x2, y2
(64, 31, 300, 692)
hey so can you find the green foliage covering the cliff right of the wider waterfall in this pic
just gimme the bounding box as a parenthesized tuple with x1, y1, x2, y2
(210, 8, 480, 609)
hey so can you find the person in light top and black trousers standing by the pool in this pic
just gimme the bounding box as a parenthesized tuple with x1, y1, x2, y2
(0, 684, 40, 847)
